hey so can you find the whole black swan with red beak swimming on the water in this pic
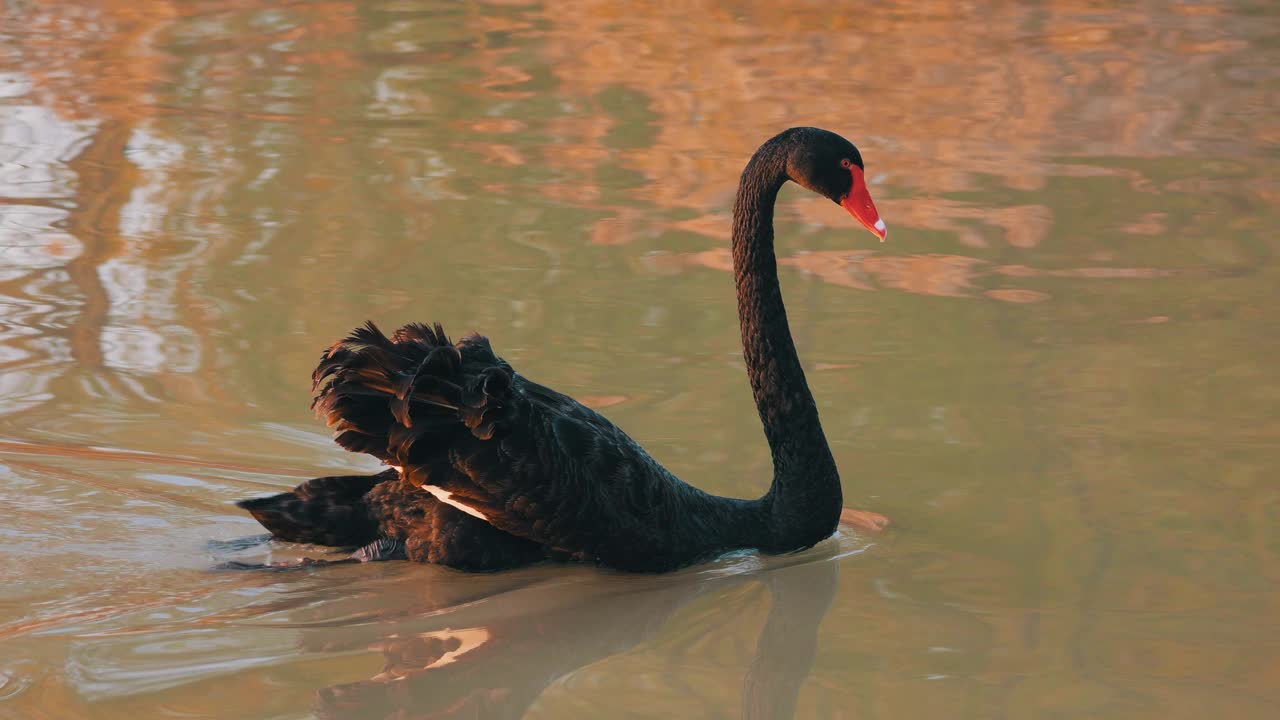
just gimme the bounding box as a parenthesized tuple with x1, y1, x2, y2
(233, 128, 886, 571)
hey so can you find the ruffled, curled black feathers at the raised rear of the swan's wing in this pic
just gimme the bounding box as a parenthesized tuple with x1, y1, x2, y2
(312, 317, 513, 465)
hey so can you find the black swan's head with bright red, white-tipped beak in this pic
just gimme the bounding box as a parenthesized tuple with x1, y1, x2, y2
(774, 128, 888, 242)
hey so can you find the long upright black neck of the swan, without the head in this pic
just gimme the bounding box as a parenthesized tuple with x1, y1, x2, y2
(733, 143, 842, 551)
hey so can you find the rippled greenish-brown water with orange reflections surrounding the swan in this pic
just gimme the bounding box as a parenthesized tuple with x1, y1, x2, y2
(0, 0, 1280, 719)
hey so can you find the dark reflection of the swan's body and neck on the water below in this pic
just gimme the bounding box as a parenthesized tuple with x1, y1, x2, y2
(303, 538, 864, 720)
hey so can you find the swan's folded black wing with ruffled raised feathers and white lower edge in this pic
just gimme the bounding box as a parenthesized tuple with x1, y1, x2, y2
(314, 323, 714, 570)
